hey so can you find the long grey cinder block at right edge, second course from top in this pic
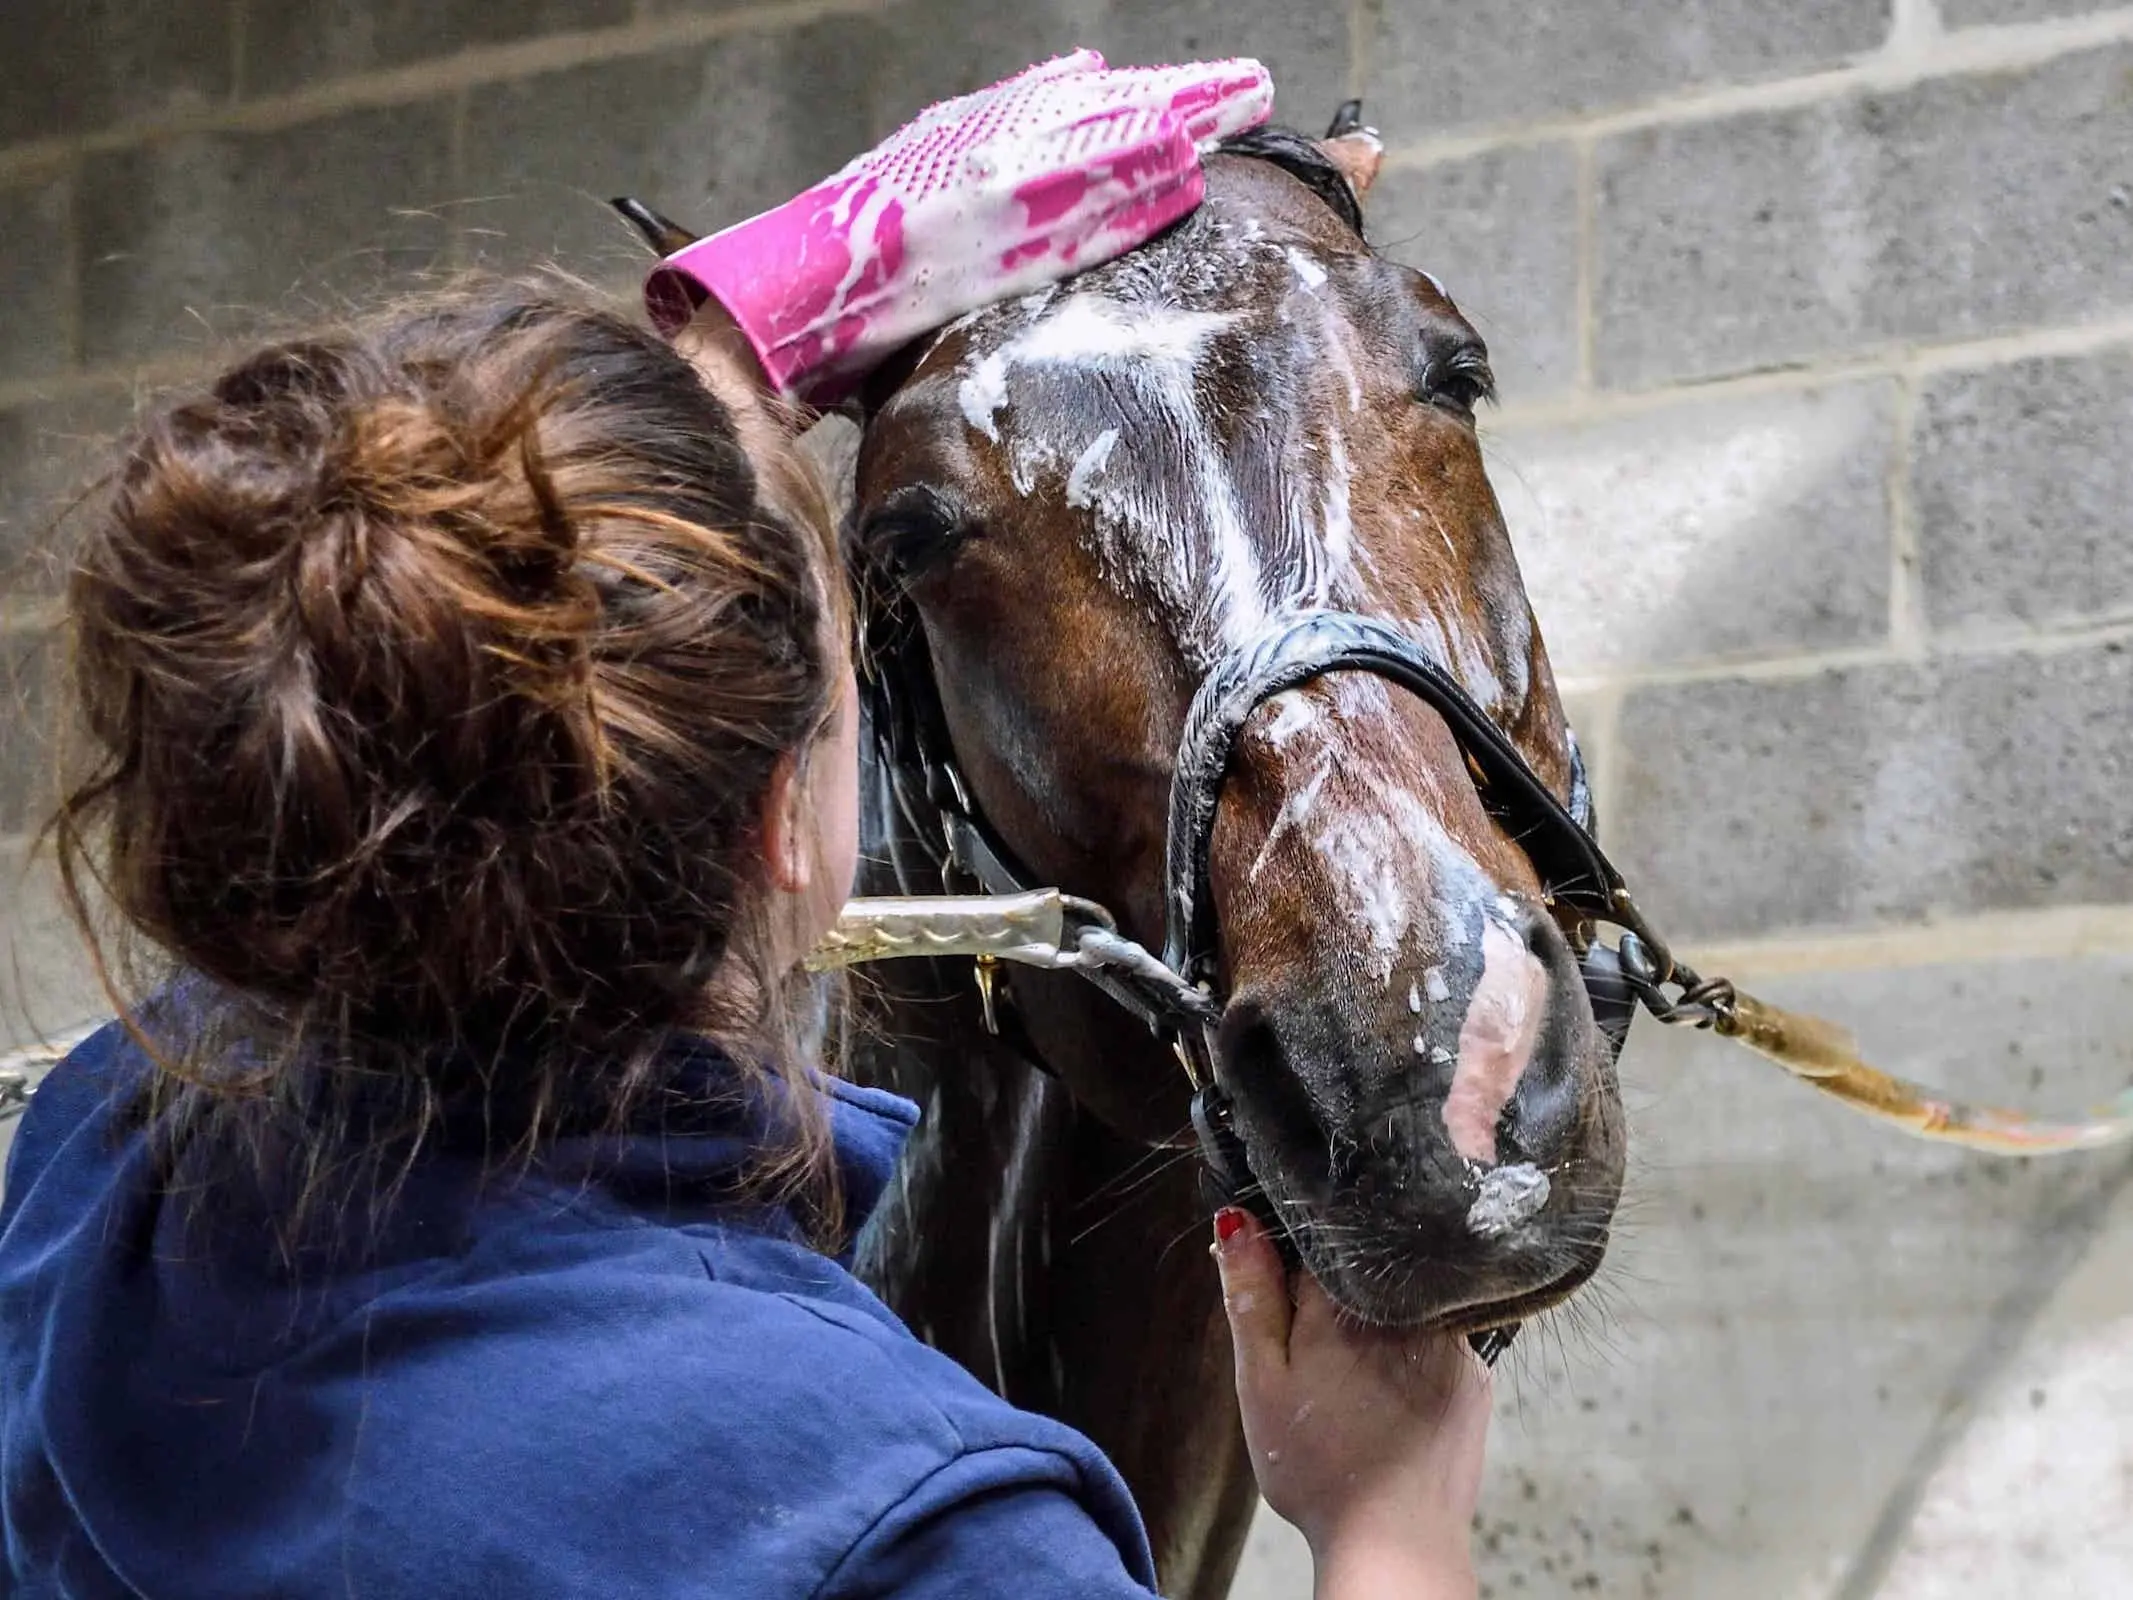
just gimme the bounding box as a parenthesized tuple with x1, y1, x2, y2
(1595, 45, 2133, 388)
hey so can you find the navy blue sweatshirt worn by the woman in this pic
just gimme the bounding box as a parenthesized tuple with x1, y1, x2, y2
(0, 1026, 1154, 1600)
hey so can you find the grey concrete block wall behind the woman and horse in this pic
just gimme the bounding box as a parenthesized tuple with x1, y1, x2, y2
(0, 0, 2133, 1600)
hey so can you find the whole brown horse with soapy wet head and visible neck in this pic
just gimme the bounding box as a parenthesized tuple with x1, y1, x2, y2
(625, 105, 1625, 1600)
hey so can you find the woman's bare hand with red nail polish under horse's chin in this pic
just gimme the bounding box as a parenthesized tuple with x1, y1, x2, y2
(1216, 1210, 1489, 1600)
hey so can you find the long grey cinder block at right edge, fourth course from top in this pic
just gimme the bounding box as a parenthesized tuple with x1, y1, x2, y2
(1602, 642, 2133, 939)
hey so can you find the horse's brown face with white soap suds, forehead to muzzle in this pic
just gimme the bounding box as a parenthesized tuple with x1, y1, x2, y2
(855, 140, 1623, 1329)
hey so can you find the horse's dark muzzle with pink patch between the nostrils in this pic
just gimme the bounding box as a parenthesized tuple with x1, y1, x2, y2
(1218, 907, 1623, 1327)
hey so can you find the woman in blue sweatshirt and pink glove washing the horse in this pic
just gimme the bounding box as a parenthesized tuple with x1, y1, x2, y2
(0, 58, 1487, 1600)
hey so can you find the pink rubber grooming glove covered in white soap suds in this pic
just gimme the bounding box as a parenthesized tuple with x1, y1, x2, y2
(644, 49, 1273, 405)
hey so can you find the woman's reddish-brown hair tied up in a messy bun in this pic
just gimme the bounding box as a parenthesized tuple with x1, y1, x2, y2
(53, 284, 845, 1229)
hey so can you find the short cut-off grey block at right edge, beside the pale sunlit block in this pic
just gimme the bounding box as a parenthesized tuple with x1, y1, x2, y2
(1911, 350, 2133, 629)
